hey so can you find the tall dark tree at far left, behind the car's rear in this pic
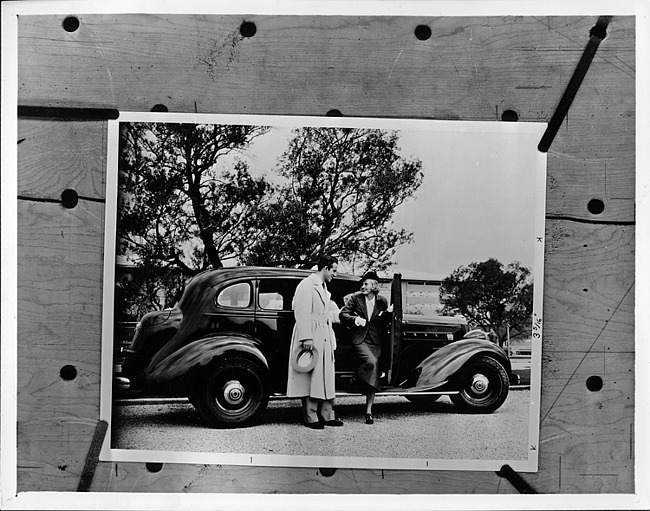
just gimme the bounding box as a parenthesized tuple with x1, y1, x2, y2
(116, 123, 272, 315)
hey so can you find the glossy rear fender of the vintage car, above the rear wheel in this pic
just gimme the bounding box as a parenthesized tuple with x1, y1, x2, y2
(145, 334, 269, 382)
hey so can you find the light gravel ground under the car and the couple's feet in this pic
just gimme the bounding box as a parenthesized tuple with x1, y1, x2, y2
(112, 389, 530, 466)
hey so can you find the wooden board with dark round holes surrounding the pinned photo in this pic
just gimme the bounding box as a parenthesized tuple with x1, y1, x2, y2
(17, 13, 635, 494)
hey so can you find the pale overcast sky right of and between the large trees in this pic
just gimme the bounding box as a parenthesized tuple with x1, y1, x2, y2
(215, 117, 546, 278)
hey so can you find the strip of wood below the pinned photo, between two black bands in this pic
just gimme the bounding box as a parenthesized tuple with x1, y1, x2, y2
(91, 463, 516, 494)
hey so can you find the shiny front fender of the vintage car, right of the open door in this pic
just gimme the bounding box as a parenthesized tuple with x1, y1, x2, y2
(415, 339, 511, 389)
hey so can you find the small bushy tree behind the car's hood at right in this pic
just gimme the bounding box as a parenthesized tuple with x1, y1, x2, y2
(440, 258, 533, 345)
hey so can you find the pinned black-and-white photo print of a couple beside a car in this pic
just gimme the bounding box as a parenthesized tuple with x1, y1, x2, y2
(102, 113, 546, 471)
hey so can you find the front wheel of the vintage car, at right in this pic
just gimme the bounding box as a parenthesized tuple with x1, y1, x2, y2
(450, 357, 510, 413)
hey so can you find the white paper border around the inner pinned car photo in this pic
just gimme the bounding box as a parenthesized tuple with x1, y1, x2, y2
(100, 112, 547, 472)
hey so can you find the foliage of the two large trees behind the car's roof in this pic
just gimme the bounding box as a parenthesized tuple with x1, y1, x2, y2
(116, 123, 422, 317)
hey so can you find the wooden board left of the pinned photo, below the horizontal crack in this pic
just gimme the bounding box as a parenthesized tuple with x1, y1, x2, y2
(17, 200, 104, 490)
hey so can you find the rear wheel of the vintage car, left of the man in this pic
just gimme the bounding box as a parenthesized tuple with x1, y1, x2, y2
(193, 357, 269, 428)
